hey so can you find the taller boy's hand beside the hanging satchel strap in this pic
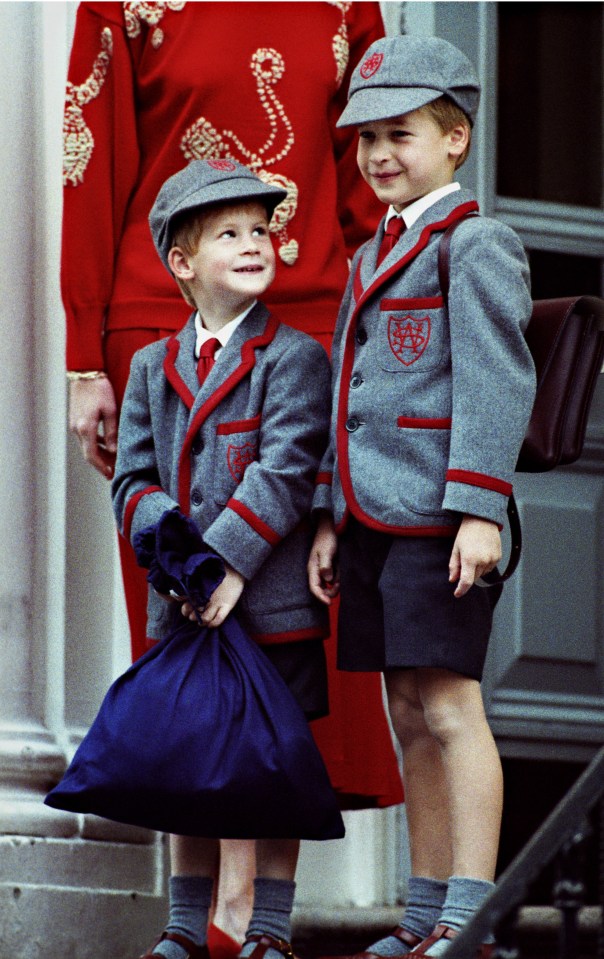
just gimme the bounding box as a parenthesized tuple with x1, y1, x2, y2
(449, 516, 501, 599)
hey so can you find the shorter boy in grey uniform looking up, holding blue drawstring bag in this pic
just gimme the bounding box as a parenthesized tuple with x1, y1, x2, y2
(112, 159, 330, 959)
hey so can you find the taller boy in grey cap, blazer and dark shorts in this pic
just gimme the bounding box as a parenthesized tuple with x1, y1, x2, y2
(309, 36, 535, 959)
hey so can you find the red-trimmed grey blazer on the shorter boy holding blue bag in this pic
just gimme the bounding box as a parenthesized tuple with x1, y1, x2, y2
(112, 303, 330, 642)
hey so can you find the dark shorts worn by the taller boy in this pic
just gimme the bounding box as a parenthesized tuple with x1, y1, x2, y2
(337, 517, 502, 680)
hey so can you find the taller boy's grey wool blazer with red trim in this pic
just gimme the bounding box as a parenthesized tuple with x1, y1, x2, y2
(313, 190, 535, 536)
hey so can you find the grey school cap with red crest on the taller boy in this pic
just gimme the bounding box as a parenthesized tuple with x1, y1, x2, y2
(337, 35, 480, 127)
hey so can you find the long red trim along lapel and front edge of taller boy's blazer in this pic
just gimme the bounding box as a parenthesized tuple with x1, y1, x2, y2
(336, 200, 478, 536)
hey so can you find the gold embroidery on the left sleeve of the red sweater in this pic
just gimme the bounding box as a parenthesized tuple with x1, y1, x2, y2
(63, 27, 113, 186)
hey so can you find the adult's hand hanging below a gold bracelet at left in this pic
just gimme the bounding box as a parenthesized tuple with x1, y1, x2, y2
(69, 377, 117, 479)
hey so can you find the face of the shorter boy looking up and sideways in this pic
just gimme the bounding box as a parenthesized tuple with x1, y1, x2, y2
(170, 201, 275, 330)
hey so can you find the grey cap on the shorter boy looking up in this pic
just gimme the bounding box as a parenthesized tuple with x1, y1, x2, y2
(149, 159, 287, 272)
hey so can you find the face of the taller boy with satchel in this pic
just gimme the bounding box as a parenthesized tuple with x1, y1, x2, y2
(357, 109, 467, 212)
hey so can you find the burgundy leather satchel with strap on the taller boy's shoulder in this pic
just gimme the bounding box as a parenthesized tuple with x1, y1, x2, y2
(438, 220, 604, 586)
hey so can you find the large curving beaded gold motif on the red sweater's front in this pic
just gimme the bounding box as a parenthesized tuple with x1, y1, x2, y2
(180, 47, 299, 266)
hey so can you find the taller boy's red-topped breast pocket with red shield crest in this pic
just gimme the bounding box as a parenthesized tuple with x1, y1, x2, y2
(378, 296, 449, 373)
